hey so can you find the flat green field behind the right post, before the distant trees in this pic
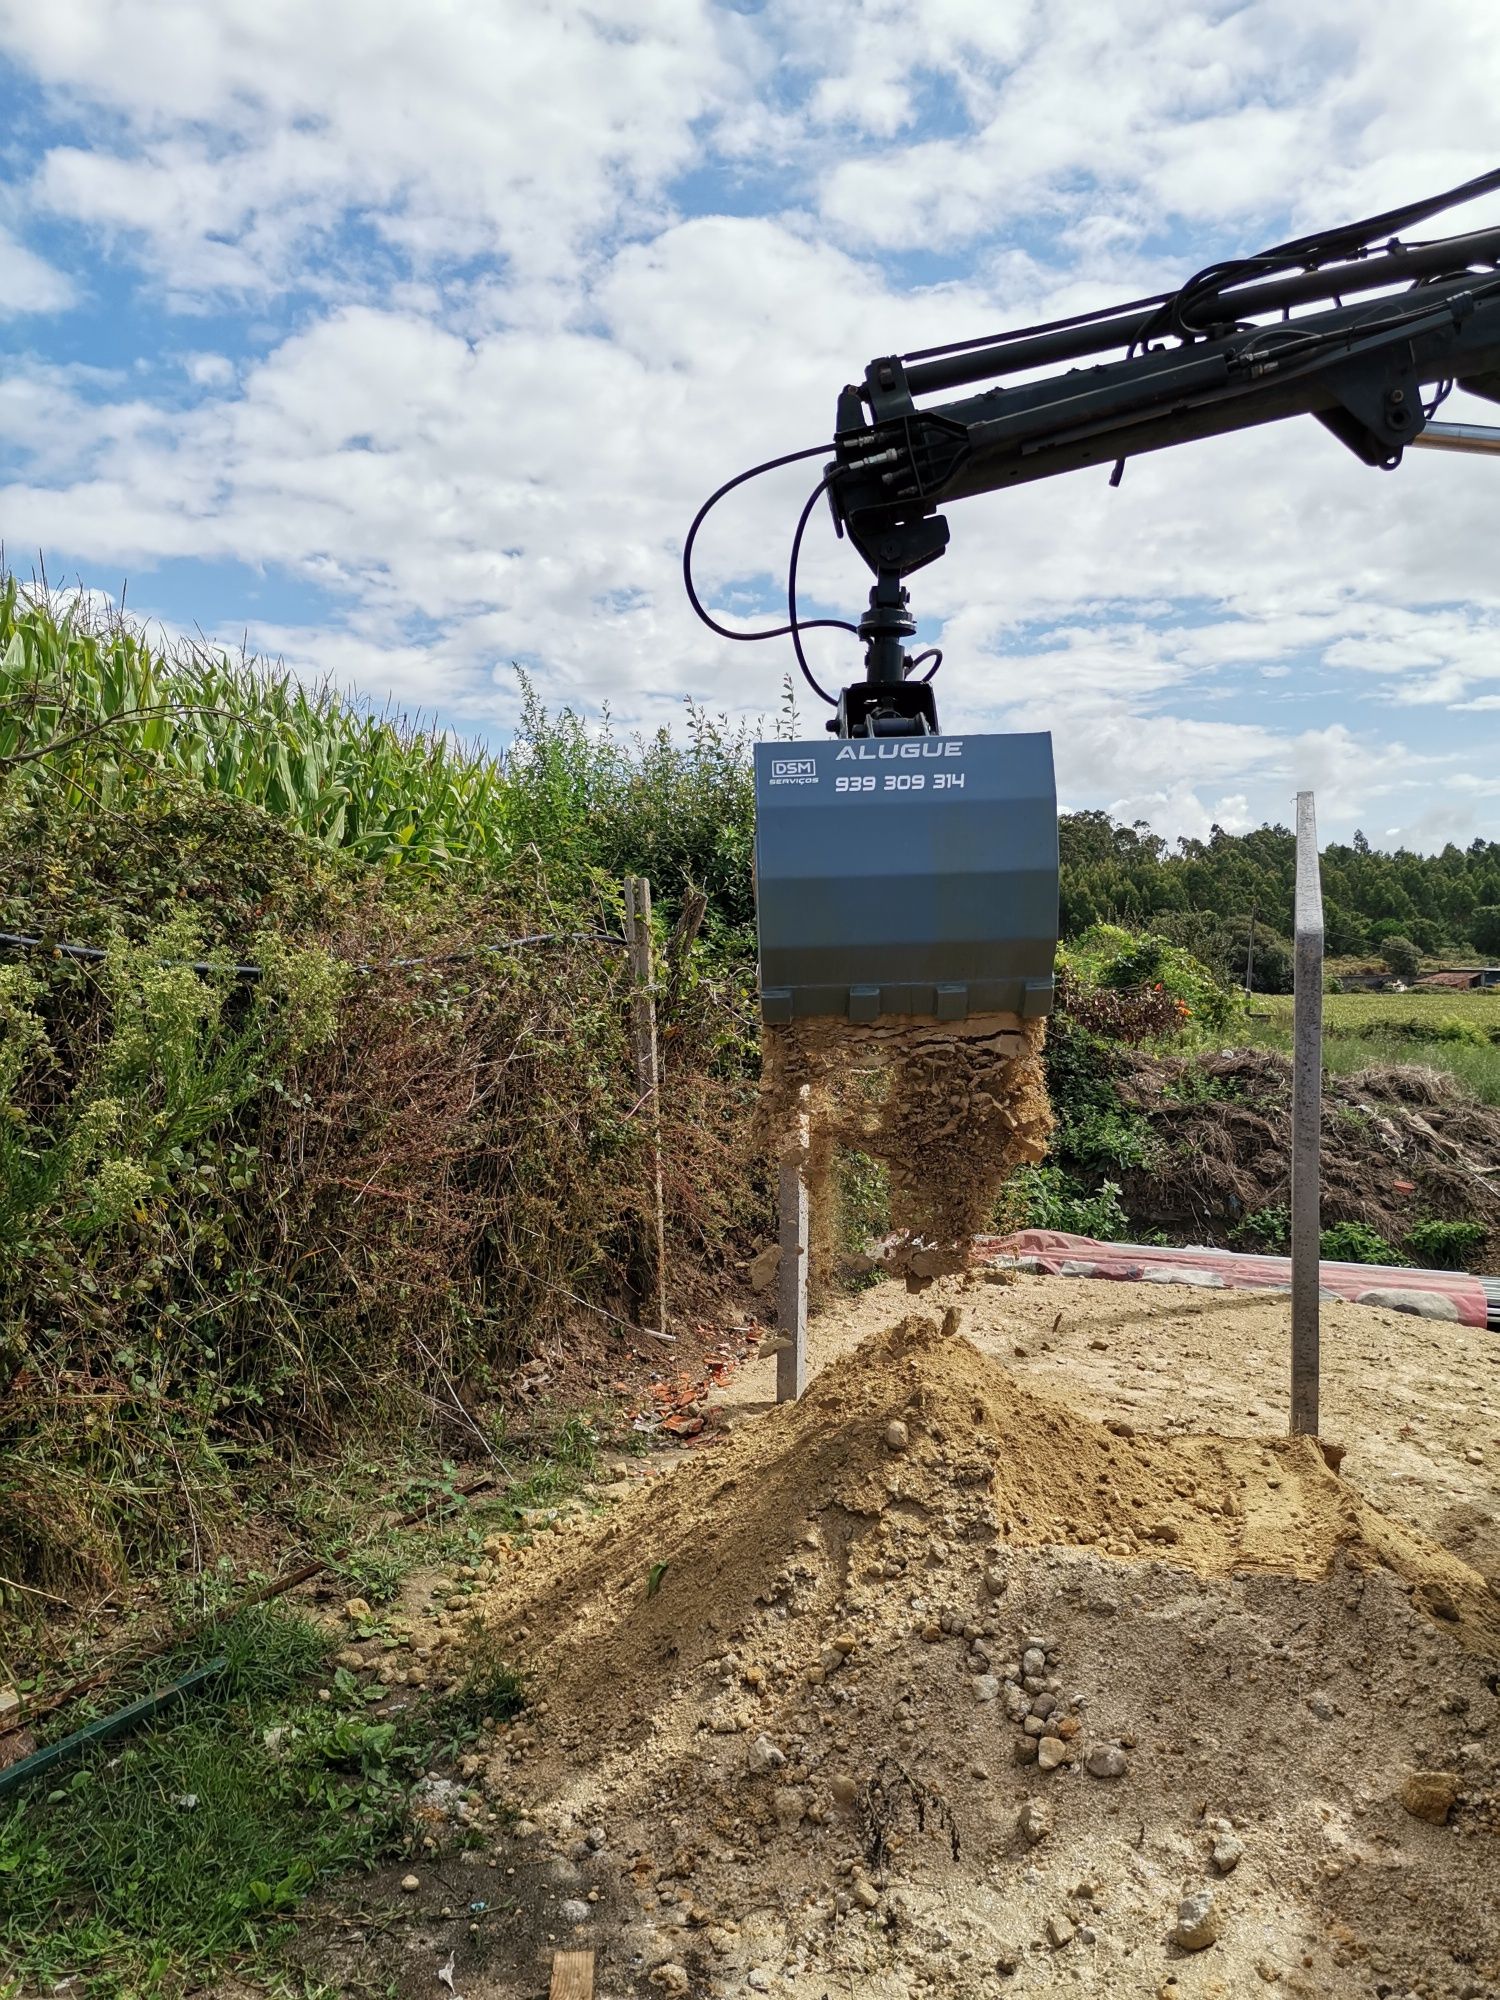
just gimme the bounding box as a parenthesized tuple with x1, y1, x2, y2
(1250, 992, 1500, 1104)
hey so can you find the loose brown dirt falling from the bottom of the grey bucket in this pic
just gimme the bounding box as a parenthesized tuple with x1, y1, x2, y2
(760, 1014, 1052, 1280)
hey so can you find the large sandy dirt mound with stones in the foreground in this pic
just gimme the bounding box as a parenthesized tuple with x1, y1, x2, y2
(468, 1314, 1500, 2000)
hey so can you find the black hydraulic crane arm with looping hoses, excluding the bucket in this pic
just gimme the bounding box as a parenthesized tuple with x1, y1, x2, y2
(684, 172, 1500, 736)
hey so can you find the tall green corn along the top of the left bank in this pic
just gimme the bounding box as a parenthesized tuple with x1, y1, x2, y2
(0, 576, 510, 868)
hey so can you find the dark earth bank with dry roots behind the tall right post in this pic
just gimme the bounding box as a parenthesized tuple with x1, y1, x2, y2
(1118, 1048, 1500, 1268)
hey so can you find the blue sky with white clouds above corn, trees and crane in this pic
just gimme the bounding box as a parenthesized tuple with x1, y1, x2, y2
(0, 0, 1500, 848)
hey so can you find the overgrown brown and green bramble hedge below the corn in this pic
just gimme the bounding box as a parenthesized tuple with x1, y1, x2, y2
(0, 844, 764, 1588)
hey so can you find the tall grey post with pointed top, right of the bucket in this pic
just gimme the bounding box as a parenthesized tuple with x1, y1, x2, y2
(1292, 792, 1322, 1438)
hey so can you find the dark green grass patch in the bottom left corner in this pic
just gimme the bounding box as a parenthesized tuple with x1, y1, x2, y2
(0, 1606, 520, 2000)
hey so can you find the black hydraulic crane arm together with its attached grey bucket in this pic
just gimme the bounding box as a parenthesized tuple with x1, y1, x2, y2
(700, 172, 1500, 1024)
